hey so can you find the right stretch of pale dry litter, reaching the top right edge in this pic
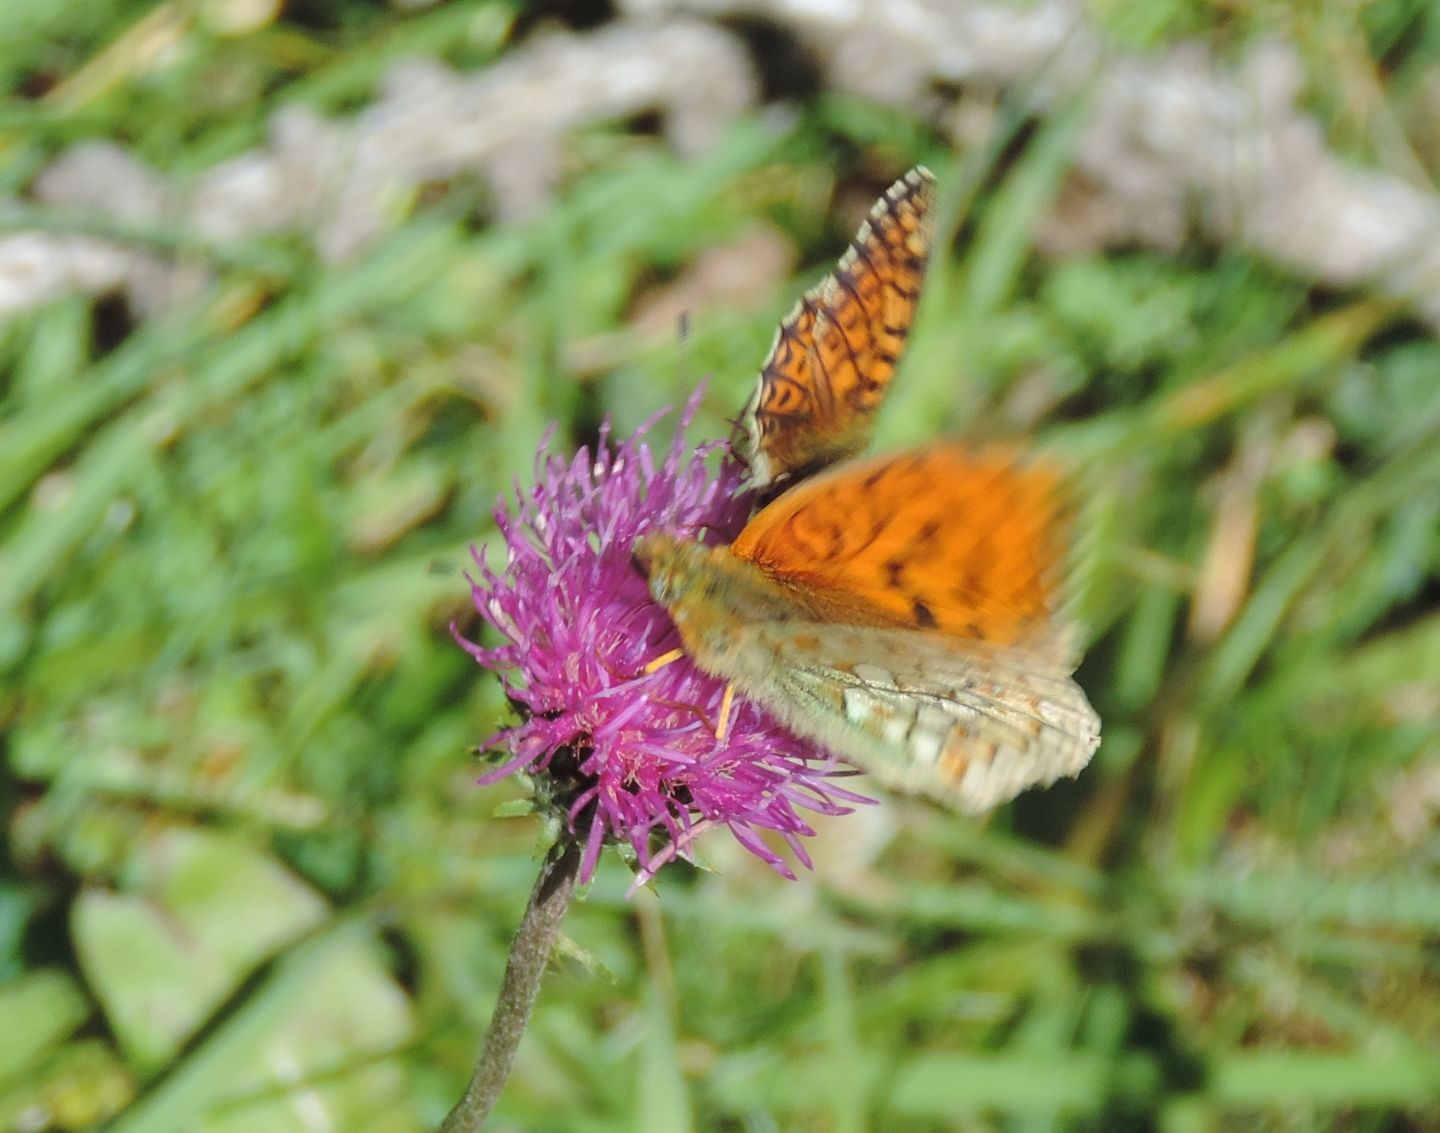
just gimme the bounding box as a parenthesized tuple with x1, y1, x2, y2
(622, 0, 1440, 325)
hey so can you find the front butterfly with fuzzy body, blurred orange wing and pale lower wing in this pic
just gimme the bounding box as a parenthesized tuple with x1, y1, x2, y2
(635, 445, 1100, 813)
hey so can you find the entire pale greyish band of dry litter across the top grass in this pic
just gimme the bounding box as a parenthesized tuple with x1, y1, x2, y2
(8, 0, 1440, 324)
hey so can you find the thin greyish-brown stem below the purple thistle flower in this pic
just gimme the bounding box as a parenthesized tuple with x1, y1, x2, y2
(439, 835, 580, 1133)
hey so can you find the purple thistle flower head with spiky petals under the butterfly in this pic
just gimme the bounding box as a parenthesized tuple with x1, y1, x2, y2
(456, 392, 870, 881)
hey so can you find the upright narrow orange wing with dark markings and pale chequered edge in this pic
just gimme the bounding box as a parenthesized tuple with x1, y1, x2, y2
(739, 166, 935, 491)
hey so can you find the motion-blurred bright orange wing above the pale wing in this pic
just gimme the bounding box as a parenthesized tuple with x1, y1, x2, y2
(730, 445, 1068, 664)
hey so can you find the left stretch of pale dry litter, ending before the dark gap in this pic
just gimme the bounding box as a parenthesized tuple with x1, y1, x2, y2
(0, 20, 757, 317)
